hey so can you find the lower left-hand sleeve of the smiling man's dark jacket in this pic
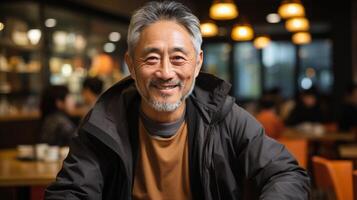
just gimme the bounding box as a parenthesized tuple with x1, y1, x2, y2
(45, 134, 103, 200)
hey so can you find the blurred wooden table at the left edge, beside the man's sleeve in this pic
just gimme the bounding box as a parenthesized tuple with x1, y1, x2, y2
(0, 149, 62, 187)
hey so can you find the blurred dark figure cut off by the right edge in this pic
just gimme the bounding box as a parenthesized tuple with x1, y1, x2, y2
(338, 84, 357, 131)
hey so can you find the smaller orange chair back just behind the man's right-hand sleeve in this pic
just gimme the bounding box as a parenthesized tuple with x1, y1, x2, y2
(278, 138, 308, 169)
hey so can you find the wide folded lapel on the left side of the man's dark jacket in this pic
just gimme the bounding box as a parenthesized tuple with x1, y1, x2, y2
(79, 77, 140, 177)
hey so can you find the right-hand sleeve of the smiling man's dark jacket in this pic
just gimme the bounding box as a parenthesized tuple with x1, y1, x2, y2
(229, 105, 310, 200)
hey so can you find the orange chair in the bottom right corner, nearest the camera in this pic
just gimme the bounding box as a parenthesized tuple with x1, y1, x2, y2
(312, 156, 353, 200)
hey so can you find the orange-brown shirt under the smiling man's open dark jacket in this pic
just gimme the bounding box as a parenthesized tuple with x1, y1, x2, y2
(133, 120, 192, 200)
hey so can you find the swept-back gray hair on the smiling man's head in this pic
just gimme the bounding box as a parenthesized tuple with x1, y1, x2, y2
(127, 1, 202, 57)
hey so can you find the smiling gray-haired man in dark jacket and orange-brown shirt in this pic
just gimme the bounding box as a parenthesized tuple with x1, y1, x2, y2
(46, 2, 309, 200)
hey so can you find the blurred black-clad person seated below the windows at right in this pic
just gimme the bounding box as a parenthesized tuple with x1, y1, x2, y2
(285, 88, 324, 126)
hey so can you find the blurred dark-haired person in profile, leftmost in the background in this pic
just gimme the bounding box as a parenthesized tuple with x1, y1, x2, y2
(40, 85, 75, 146)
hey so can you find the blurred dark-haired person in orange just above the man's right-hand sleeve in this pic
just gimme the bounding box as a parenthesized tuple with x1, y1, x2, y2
(256, 96, 284, 139)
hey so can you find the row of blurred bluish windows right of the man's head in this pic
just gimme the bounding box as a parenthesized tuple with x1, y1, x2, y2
(203, 39, 333, 101)
